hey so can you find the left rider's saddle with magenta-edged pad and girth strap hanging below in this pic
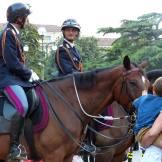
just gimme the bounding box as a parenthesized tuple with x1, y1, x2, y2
(0, 86, 49, 160)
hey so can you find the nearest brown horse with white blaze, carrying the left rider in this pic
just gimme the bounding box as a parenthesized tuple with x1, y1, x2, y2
(0, 57, 147, 162)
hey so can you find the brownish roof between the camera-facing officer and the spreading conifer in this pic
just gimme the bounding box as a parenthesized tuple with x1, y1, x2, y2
(98, 38, 116, 47)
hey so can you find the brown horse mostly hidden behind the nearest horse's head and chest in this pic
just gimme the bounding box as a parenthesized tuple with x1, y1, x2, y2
(92, 69, 162, 162)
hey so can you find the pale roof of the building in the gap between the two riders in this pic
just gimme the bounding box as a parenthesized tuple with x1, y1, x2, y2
(0, 23, 61, 33)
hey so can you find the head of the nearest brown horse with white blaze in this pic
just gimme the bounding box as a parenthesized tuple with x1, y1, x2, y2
(114, 56, 149, 113)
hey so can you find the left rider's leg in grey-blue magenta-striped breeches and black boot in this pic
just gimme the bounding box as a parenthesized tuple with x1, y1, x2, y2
(4, 85, 28, 159)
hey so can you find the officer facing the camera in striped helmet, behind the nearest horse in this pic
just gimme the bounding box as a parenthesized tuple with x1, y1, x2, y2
(55, 19, 82, 76)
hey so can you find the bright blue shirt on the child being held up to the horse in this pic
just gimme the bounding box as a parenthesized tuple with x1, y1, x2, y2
(133, 94, 162, 133)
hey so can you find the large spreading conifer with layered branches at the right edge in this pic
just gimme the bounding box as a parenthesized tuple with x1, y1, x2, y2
(99, 13, 162, 68)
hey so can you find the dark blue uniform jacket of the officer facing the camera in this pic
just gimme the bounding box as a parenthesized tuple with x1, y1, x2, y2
(55, 40, 82, 76)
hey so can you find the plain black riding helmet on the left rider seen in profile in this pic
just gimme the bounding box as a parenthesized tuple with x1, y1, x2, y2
(7, 3, 31, 23)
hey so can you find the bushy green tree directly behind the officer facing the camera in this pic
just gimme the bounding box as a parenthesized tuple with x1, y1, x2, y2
(46, 37, 103, 78)
